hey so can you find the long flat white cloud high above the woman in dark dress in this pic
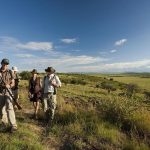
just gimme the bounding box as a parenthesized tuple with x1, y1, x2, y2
(16, 42, 53, 51)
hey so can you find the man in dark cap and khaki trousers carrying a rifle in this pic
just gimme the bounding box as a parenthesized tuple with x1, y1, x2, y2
(0, 58, 17, 132)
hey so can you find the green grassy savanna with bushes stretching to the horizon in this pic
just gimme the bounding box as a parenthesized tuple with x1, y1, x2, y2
(0, 73, 150, 150)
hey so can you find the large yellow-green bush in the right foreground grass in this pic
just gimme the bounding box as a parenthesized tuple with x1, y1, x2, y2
(99, 97, 139, 131)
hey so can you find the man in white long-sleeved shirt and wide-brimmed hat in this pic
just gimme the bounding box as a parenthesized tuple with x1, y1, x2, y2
(42, 67, 61, 125)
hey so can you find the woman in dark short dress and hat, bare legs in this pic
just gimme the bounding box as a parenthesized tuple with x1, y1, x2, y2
(29, 69, 42, 119)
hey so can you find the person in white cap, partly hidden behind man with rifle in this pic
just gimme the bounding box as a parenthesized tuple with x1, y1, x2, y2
(12, 66, 20, 108)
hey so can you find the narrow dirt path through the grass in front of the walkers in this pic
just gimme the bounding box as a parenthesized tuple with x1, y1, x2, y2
(16, 108, 59, 150)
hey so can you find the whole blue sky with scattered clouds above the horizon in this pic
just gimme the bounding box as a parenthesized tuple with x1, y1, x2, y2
(0, 0, 150, 72)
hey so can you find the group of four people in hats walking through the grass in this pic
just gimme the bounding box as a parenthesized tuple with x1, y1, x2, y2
(0, 58, 61, 132)
